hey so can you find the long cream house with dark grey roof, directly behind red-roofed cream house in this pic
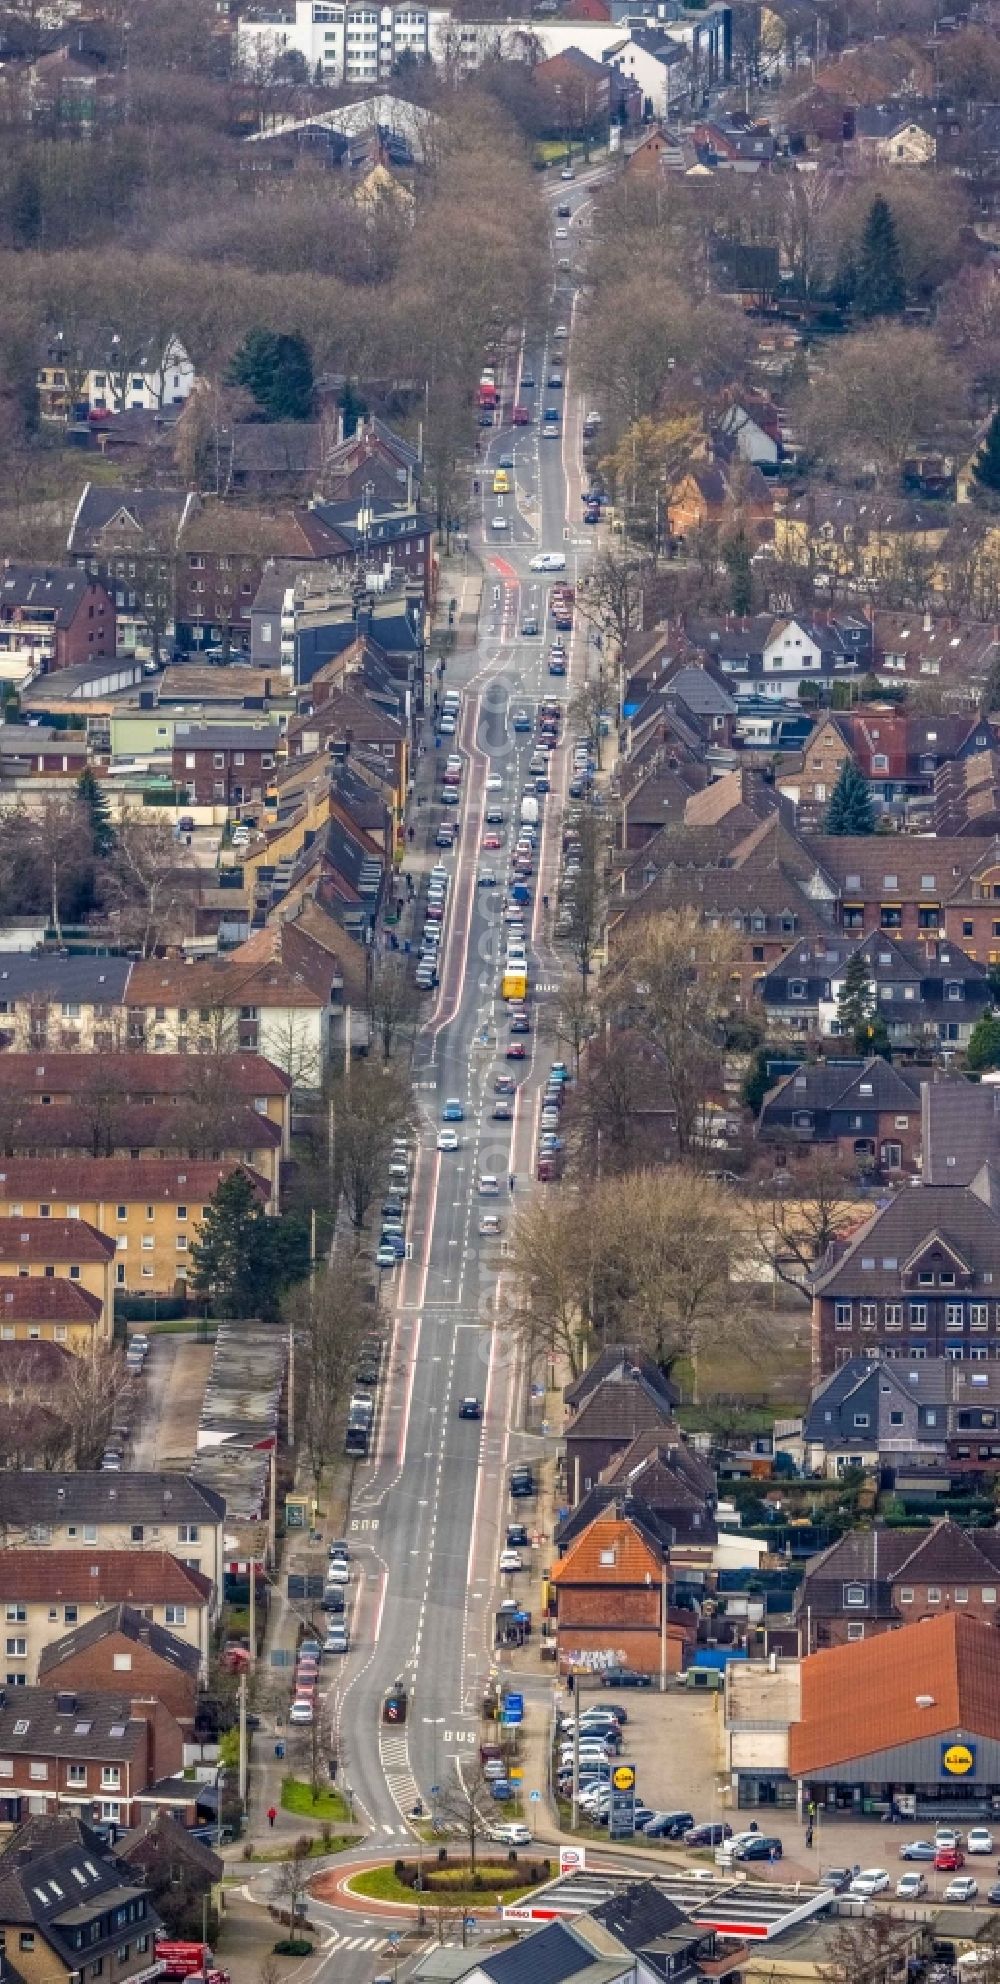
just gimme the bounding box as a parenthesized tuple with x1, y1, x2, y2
(0, 1468, 226, 1591)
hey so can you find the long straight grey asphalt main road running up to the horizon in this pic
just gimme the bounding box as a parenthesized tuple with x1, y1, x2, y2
(301, 175, 607, 1984)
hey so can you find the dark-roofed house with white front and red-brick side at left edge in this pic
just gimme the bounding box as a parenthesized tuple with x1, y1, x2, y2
(0, 561, 115, 686)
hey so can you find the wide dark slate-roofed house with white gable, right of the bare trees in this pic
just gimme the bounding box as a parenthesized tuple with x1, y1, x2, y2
(760, 930, 992, 1048)
